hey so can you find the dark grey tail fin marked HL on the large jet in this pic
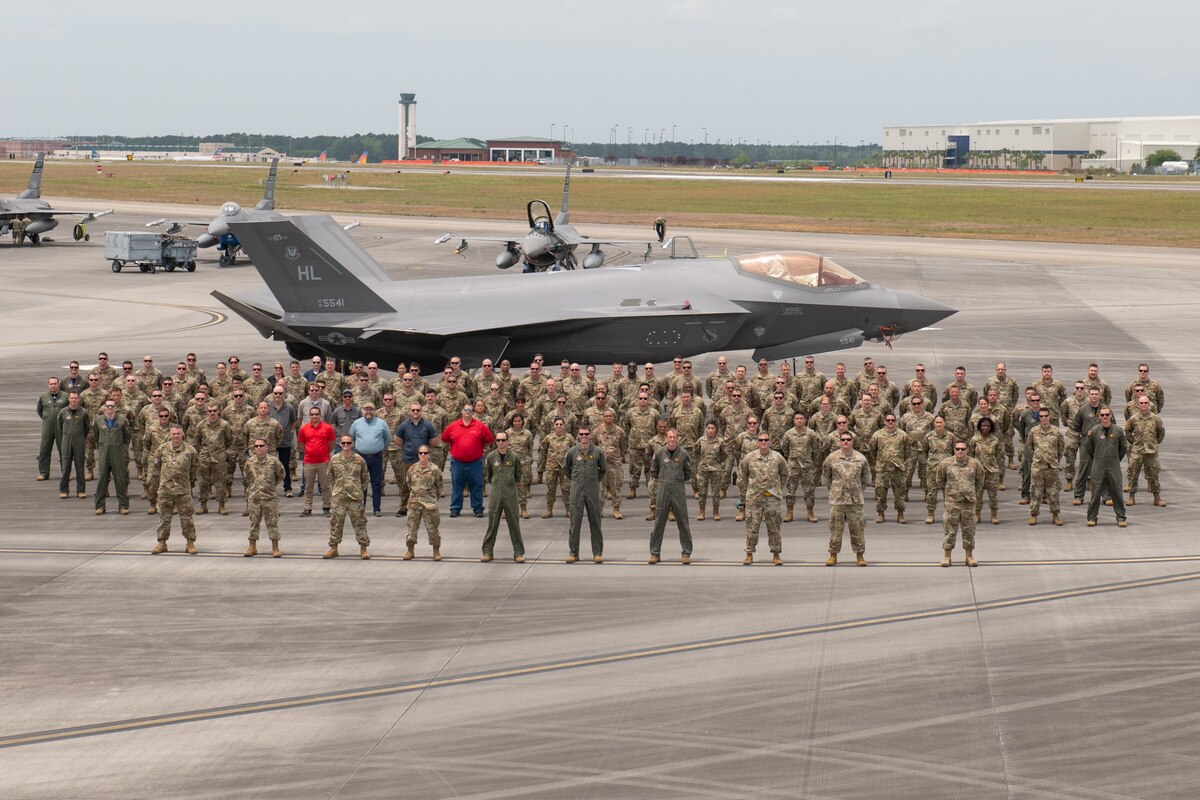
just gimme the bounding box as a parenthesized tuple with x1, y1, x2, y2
(229, 219, 395, 314)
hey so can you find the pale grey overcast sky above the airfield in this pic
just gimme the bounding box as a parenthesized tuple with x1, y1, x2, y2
(11, 0, 1200, 144)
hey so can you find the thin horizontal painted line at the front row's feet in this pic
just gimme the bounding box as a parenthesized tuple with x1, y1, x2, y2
(0, 542, 1200, 570)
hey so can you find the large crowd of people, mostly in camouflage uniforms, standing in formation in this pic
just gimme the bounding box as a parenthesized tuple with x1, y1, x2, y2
(36, 353, 1166, 566)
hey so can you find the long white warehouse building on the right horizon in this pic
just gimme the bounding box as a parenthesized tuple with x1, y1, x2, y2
(883, 116, 1200, 172)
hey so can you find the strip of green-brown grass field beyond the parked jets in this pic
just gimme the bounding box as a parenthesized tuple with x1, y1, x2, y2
(9, 162, 1200, 247)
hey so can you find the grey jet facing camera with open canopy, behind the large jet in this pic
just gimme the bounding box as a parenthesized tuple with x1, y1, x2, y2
(433, 164, 655, 272)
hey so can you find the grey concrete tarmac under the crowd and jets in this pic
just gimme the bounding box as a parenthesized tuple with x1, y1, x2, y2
(0, 204, 1200, 799)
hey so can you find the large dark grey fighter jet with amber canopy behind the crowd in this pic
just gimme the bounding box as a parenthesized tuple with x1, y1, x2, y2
(212, 216, 955, 372)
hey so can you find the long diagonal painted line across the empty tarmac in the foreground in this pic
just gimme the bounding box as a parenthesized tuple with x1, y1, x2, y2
(0, 572, 1200, 748)
